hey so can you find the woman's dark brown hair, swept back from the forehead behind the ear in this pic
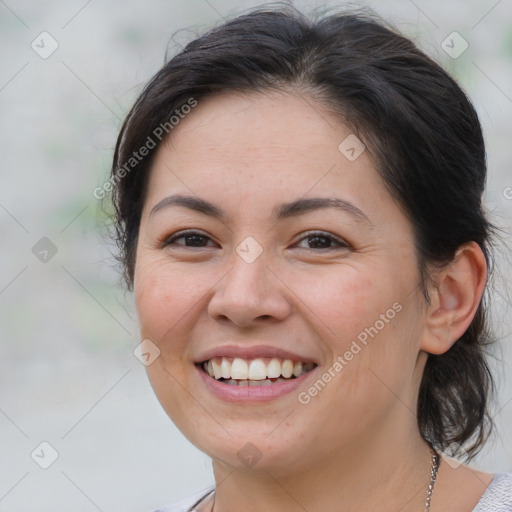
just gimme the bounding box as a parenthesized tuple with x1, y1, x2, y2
(111, 5, 495, 460)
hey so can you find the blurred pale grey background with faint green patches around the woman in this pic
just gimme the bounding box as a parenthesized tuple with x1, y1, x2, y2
(0, 0, 512, 512)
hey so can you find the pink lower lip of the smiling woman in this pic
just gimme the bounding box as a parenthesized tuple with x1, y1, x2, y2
(196, 365, 318, 402)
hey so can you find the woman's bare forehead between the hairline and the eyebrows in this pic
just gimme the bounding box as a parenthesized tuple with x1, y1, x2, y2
(141, 92, 400, 230)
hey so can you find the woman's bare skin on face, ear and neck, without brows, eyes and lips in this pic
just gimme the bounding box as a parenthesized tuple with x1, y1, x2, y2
(134, 91, 492, 512)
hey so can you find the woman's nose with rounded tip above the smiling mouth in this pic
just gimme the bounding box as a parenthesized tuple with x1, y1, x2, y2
(208, 249, 292, 327)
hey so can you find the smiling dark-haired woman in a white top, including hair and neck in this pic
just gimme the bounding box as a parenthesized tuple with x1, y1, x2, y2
(111, 7, 512, 512)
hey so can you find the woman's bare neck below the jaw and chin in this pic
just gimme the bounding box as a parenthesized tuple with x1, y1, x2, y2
(213, 410, 431, 512)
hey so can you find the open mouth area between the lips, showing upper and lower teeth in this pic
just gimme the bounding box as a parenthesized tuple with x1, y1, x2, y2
(200, 357, 316, 387)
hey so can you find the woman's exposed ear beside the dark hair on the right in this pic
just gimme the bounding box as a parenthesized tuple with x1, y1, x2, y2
(420, 242, 487, 354)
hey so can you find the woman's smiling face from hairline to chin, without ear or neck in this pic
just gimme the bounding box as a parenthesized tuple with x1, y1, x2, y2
(135, 93, 426, 470)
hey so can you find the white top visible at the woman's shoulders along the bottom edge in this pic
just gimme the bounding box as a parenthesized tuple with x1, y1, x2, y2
(155, 473, 512, 512)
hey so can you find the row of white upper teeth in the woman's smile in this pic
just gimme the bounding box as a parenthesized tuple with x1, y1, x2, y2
(203, 357, 315, 380)
